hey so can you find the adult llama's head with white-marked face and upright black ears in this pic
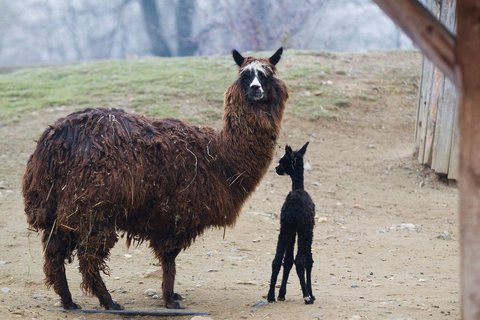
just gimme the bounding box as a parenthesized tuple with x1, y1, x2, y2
(232, 48, 283, 101)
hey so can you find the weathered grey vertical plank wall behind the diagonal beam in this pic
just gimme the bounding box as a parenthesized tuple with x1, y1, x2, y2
(415, 0, 458, 180)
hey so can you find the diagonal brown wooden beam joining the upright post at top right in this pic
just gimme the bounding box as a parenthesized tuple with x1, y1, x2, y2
(373, 0, 456, 83)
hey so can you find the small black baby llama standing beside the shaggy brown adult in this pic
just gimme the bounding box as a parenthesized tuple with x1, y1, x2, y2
(267, 142, 315, 304)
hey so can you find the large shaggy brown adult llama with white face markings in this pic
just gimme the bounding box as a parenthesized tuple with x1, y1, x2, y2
(23, 48, 288, 309)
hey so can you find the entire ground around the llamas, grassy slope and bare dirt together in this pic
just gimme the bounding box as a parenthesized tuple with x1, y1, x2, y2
(0, 51, 460, 320)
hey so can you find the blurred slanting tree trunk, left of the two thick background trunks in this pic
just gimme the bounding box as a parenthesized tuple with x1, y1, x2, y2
(140, 0, 172, 57)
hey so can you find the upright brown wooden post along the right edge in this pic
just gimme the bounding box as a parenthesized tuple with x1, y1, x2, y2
(455, 0, 480, 320)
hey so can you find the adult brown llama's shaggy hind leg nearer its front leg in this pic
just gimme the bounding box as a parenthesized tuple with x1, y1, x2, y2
(77, 231, 123, 310)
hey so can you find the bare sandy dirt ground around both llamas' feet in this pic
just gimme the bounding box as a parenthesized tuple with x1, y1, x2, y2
(0, 54, 460, 320)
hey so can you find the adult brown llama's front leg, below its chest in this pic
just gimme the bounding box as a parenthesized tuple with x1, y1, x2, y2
(162, 249, 184, 309)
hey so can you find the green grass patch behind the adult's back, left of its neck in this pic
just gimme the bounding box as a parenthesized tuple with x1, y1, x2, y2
(0, 57, 236, 122)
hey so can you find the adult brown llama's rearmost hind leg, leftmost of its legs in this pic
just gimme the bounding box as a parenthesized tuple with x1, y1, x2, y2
(42, 230, 81, 310)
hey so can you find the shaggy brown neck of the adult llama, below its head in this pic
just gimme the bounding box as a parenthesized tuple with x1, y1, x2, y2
(218, 80, 288, 224)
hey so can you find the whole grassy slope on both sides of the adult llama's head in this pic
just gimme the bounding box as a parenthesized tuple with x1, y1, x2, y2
(0, 50, 420, 124)
